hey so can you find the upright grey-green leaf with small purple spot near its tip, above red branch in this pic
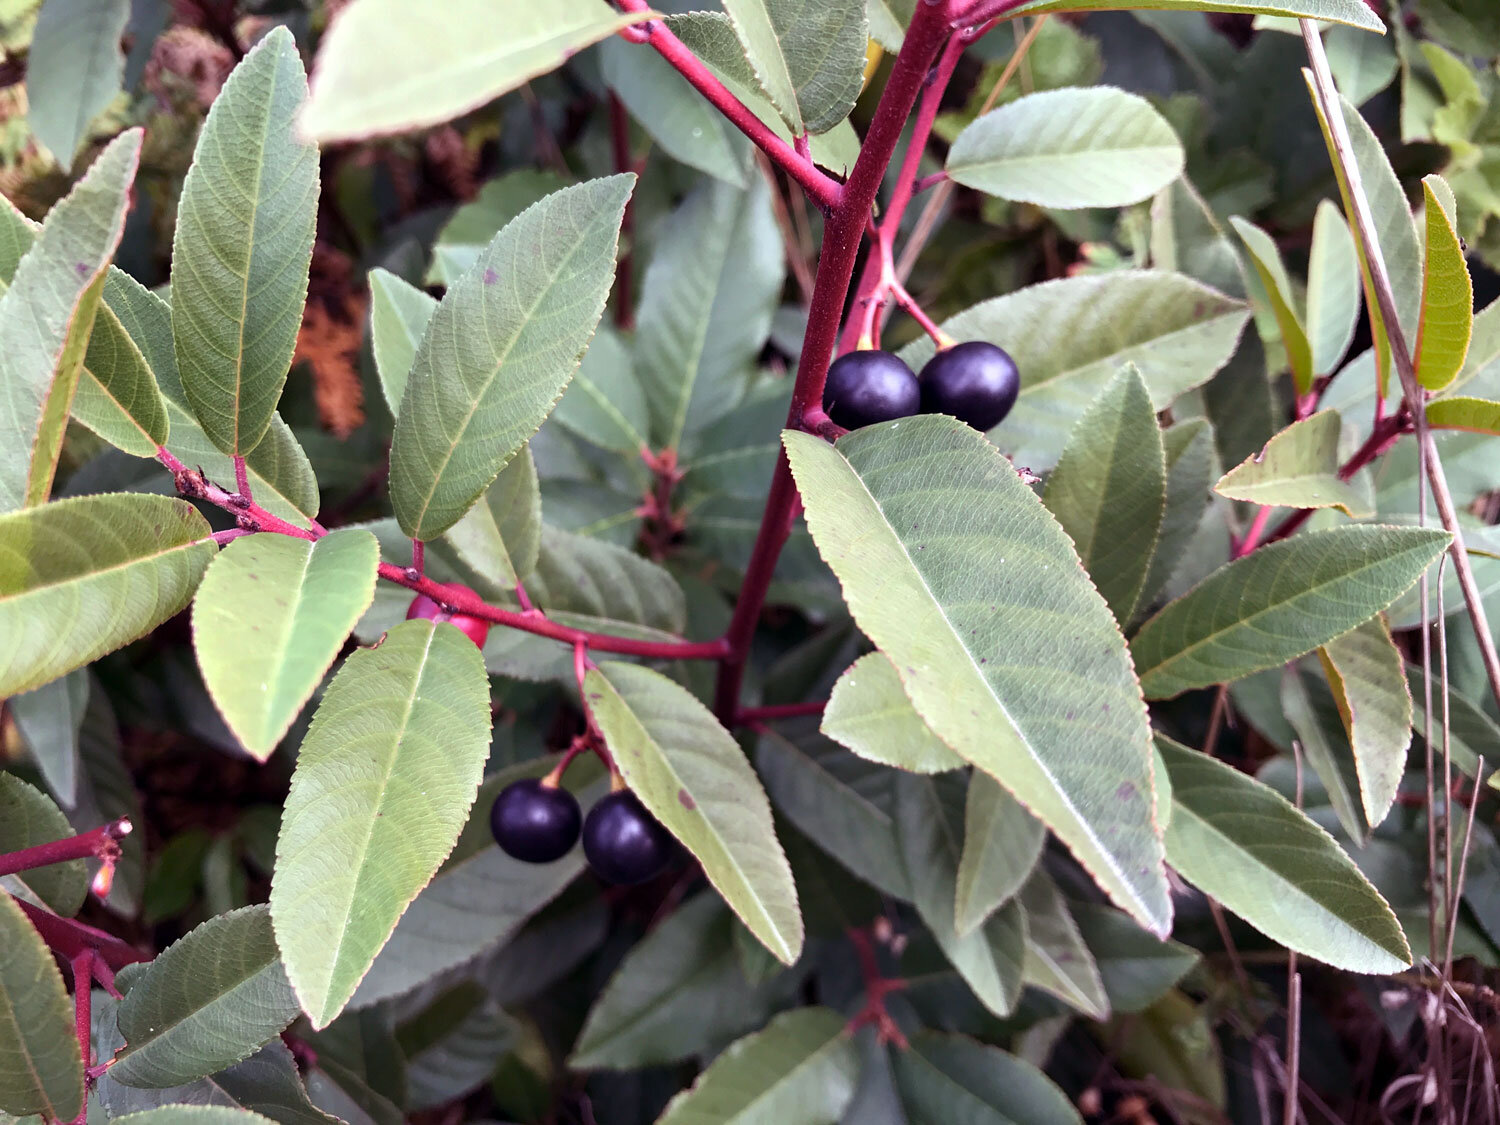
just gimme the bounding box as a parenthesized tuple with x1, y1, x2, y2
(390, 174, 636, 540)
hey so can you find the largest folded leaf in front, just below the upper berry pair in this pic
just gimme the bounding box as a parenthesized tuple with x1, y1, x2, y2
(783, 416, 1172, 932)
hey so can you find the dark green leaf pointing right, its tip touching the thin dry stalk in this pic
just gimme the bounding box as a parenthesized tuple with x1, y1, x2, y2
(1131, 524, 1449, 699)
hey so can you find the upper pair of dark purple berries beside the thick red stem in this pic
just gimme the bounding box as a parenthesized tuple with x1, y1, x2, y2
(824, 341, 1022, 434)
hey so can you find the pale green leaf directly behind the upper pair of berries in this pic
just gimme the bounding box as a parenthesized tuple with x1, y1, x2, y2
(899, 270, 1250, 471)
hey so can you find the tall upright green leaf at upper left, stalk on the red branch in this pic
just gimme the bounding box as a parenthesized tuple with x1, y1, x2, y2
(173, 27, 318, 458)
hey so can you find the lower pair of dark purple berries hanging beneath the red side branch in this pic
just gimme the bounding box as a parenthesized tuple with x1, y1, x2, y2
(489, 776, 674, 887)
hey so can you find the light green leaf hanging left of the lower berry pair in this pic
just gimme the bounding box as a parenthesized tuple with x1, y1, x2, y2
(272, 621, 489, 1028)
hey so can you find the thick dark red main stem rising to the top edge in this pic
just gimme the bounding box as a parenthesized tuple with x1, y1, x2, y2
(714, 0, 950, 719)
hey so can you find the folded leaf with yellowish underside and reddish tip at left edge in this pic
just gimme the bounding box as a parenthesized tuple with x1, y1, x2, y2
(0, 129, 141, 512)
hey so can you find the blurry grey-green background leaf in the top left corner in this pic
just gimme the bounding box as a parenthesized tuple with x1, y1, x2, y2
(26, 0, 131, 173)
